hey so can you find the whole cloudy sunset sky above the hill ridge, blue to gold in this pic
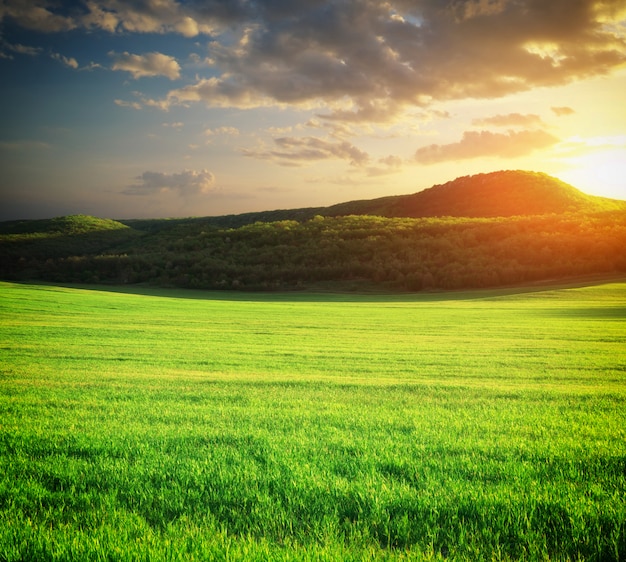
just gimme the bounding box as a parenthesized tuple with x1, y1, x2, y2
(0, 0, 626, 220)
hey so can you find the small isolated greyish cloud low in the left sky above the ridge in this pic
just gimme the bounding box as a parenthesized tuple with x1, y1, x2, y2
(123, 170, 215, 196)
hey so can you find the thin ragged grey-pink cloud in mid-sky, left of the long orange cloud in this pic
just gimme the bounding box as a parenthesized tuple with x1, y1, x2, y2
(243, 137, 369, 166)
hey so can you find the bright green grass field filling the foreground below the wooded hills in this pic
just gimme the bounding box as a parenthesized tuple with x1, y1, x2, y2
(0, 283, 626, 562)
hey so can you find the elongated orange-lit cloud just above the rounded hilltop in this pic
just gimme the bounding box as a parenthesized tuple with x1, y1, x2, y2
(415, 129, 559, 164)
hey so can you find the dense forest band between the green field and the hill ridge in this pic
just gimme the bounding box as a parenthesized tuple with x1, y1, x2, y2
(0, 171, 626, 291)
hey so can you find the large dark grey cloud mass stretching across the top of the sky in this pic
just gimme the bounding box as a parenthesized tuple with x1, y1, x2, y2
(0, 0, 626, 122)
